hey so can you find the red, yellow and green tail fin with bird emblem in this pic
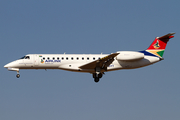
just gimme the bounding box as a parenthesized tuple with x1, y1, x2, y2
(146, 33, 175, 58)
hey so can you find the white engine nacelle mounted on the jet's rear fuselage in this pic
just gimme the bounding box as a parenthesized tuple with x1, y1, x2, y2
(116, 51, 144, 61)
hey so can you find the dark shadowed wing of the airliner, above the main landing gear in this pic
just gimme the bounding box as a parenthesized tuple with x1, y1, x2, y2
(79, 53, 119, 70)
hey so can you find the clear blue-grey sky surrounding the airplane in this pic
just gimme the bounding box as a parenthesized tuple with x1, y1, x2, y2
(0, 0, 180, 120)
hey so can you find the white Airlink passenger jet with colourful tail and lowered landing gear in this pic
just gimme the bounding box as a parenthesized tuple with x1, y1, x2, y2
(4, 33, 175, 82)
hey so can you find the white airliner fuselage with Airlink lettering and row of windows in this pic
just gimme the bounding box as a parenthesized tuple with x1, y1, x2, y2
(4, 51, 160, 73)
